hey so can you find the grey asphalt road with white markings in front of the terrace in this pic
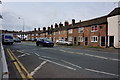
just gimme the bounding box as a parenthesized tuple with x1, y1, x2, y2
(4, 42, 120, 78)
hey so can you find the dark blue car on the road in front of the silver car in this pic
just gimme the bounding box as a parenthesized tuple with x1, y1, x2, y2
(36, 38, 54, 47)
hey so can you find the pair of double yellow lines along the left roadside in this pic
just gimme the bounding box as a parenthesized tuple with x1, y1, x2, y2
(7, 49, 34, 80)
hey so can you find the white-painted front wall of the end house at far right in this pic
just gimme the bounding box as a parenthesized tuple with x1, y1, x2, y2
(107, 15, 120, 48)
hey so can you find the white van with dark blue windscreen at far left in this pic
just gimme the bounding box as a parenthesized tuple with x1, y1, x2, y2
(2, 34, 14, 45)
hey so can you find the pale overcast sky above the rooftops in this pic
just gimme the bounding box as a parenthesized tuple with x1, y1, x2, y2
(2, 2, 117, 31)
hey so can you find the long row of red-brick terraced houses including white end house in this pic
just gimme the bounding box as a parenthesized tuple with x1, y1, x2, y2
(2, 7, 120, 48)
